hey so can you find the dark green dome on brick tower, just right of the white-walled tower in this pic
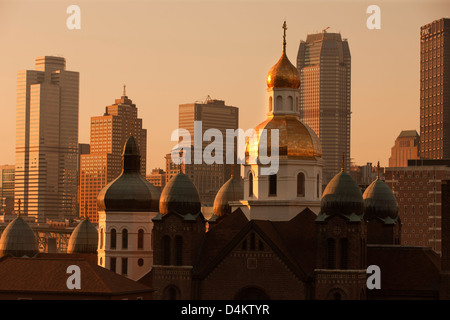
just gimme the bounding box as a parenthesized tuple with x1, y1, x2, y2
(159, 172, 201, 215)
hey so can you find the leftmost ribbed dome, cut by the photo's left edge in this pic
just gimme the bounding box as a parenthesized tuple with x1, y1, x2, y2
(0, 215, 39, 257)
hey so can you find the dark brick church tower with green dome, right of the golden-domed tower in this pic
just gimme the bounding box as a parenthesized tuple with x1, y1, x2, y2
(314, 158, 367, 300)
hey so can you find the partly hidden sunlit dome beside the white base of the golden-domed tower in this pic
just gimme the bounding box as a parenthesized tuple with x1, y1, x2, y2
(211, 175, 244, 220)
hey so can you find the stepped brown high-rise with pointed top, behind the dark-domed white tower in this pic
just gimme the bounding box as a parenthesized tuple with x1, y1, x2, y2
(79, 87, 147, 223)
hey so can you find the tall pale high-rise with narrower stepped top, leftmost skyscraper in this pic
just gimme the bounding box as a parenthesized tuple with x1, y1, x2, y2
(15, 56, 80, 222)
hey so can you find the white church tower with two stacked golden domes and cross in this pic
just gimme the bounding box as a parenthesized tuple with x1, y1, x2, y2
(232, 21, 323, 221)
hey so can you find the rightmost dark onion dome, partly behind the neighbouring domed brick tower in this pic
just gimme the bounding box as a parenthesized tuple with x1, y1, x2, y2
(363, 164, 398, 222)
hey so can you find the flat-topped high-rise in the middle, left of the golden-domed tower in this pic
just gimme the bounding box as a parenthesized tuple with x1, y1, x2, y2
(175, 96, 240, 205)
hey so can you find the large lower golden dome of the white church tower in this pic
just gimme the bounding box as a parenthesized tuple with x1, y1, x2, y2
(245, 114, 322, 162)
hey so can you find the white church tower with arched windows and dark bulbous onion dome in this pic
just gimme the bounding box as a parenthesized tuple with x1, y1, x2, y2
(97, 136, 160, 280)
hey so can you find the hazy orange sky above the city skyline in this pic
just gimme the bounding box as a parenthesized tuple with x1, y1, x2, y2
(0, 0, 450, 172)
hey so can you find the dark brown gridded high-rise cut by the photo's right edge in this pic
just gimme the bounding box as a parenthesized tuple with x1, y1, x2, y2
(420, 18, 450, 159)
